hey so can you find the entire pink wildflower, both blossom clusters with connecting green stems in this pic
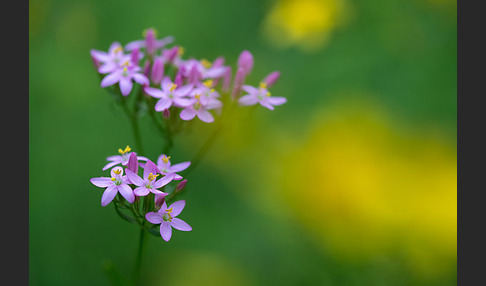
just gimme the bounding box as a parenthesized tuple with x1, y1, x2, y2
(90, 29, 287, 244)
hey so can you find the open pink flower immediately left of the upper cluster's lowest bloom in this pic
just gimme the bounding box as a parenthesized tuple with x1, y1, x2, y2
(144, 77, 192, 111)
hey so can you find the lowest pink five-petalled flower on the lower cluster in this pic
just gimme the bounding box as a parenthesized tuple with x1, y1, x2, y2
(145, 201, 192, 241)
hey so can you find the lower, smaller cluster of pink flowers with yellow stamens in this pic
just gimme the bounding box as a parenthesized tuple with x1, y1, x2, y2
(90, 146, 192, 241)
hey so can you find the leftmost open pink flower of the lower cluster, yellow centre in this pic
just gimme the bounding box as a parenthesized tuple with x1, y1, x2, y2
(90, 166, 135, 207)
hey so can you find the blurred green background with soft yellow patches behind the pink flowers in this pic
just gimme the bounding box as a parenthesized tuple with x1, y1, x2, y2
(29, 0, 457, 286)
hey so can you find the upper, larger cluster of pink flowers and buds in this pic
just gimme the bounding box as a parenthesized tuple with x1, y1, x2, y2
(91, 29, 287, 123)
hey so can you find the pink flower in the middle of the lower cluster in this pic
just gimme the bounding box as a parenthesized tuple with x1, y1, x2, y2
(126, 160, 172, 197)
